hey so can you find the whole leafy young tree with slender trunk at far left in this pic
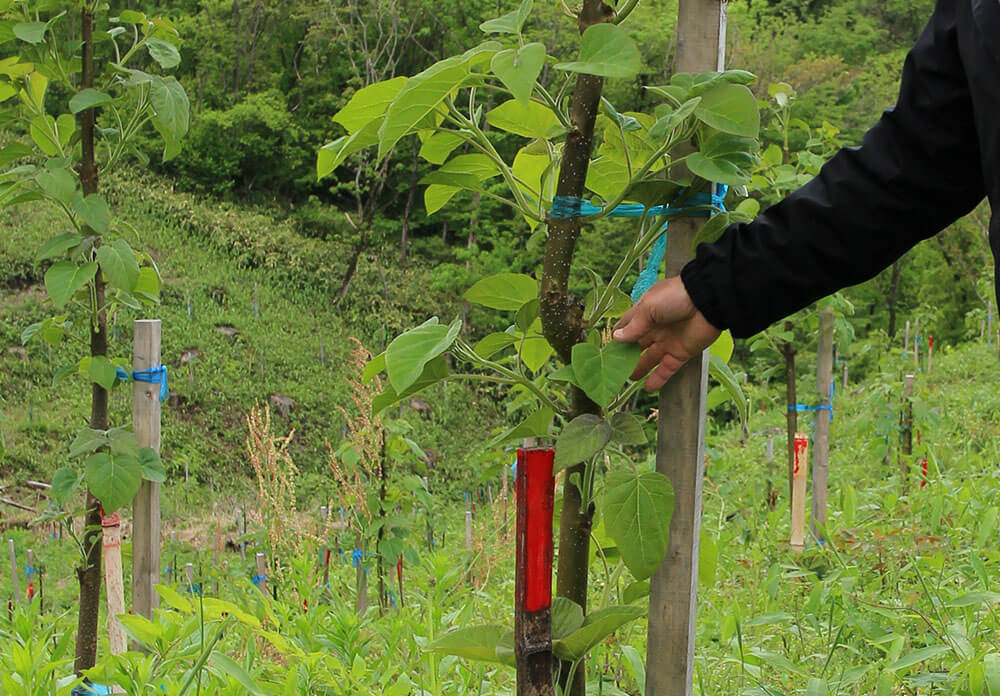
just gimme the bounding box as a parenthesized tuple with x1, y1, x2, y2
(10, 0, 188, 673)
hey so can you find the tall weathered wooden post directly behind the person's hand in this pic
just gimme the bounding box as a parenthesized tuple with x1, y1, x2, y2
(646, 0, 726, 696)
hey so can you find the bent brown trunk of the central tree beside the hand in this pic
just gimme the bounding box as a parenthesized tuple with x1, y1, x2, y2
(539, 0, 613, 696)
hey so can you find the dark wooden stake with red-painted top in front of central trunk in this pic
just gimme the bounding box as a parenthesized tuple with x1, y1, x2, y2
(514, 447, 555, 696)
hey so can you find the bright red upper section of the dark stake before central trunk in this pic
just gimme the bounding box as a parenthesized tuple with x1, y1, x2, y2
(515, 447, 555, 612)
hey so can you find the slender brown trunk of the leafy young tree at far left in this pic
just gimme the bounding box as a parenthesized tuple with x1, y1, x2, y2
(74, 3, 108, 674)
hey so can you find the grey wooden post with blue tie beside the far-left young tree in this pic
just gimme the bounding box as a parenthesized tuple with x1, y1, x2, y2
(132, 319, 162, 619)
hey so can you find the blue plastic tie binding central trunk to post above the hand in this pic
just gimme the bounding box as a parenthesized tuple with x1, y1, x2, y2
(549, 184, 729, 303)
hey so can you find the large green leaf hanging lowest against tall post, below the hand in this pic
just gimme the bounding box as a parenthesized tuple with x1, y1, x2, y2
(601, 470, 674, 580)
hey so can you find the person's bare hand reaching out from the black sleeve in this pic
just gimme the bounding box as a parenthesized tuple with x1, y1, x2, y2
(612, 276, 722, 391)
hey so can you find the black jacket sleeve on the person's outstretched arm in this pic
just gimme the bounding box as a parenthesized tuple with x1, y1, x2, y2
(681, 0, 985, 338)
